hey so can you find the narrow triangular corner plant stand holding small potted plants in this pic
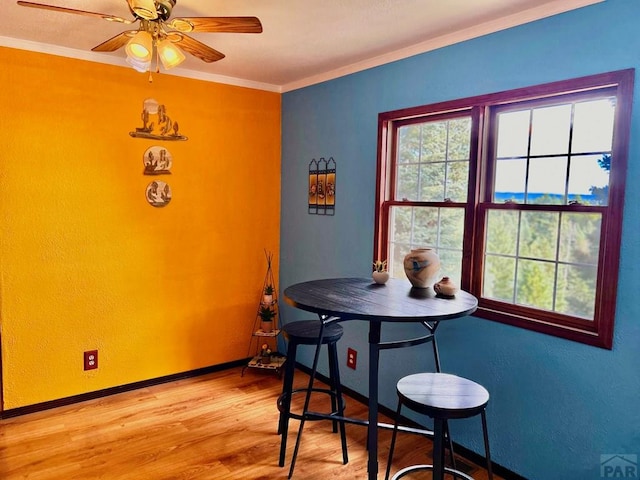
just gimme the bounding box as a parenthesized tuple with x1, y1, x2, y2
(242, 251, 286, 375)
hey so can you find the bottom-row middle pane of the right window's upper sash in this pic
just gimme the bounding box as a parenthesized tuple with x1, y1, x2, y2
(526, 157, 567, 205)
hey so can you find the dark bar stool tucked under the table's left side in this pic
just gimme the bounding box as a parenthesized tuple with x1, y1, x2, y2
(278, 320, 349, 478)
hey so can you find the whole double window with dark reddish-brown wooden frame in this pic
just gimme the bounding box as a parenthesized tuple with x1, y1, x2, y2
(374, 70, 634, 348)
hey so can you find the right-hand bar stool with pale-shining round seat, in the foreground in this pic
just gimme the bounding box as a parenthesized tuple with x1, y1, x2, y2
(385, 373, 493, 480)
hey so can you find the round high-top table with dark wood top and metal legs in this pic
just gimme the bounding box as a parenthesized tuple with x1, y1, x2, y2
(284, 278, 478, 480)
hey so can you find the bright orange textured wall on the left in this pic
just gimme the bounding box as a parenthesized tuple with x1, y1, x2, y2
(0, 48, 280, 409)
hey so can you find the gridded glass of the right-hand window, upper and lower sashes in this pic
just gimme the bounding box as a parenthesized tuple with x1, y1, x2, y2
(481, 94, 616, 322)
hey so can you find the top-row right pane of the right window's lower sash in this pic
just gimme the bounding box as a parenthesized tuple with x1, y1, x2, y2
(559, 213, 601, 264)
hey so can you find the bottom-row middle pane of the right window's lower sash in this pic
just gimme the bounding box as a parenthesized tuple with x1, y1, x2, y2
(515, 259, 555, 310)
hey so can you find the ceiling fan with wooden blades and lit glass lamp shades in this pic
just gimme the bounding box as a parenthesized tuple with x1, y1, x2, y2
(18, 0, 262, 72)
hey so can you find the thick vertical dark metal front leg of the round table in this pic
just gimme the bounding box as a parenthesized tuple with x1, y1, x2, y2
(367, 321, 381, 480)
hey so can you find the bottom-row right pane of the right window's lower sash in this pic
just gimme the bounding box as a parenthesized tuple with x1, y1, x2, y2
(556, 265, 597, 320)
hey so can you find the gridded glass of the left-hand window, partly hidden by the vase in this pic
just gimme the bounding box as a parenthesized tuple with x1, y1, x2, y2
(387, 113, 472, 281)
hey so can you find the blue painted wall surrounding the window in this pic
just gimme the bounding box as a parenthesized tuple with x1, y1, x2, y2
(280, 0, 640, 480)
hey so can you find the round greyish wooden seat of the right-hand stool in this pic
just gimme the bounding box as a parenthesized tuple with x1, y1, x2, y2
(397, 373, 489, 419)
